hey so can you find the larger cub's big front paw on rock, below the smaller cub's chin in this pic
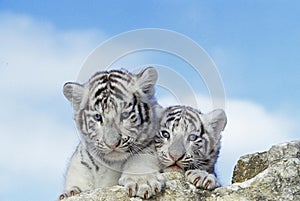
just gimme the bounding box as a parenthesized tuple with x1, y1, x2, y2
(119, 173, 165, 199)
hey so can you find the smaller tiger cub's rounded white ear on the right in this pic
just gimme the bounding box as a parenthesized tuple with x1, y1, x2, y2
(202, 109, 227, 138)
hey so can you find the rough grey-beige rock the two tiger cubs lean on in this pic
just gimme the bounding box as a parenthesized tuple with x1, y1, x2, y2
(62, 141, 300, 201)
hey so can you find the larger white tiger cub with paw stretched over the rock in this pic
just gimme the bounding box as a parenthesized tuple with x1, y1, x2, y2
(60, 67, 164, 199)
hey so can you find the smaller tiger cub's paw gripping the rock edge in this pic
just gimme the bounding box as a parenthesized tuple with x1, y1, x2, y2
(185, 170, 220, 190)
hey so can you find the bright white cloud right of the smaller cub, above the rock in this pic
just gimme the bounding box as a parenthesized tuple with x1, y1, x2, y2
(218, 99, 297, 184)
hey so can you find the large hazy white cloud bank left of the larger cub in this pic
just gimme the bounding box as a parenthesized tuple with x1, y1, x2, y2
(0, 13, 104, 200)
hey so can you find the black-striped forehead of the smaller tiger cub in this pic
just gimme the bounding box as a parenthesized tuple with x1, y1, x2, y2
(160, 106, 203, 136)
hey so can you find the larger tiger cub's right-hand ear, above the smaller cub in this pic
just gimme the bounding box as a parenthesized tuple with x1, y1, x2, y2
(137, 67, 157, 97)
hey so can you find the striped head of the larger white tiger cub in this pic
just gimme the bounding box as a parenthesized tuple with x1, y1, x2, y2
(63, 67, 157, 164)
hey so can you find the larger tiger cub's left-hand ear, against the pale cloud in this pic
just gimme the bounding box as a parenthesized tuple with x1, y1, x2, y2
(63, 82, 84, 111)
